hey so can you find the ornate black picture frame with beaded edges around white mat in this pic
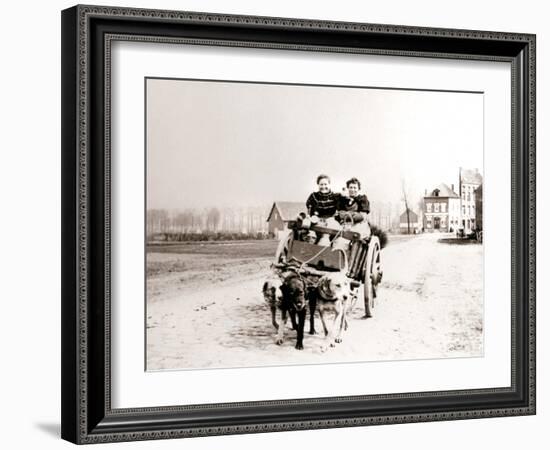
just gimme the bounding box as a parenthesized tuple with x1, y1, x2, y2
(62, 6, 535, 444)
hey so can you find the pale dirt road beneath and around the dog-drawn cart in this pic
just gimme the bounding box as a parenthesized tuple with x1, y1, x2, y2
(147, 234, 483, 370)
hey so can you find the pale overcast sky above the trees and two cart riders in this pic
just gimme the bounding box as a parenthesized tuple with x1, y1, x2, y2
(147, 79, 483, 209)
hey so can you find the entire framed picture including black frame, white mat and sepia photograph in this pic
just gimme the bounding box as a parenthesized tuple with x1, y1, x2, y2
(60, 5, 540, 442)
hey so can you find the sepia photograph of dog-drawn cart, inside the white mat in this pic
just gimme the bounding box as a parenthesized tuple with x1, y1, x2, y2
(144, 78, 484, 371)
